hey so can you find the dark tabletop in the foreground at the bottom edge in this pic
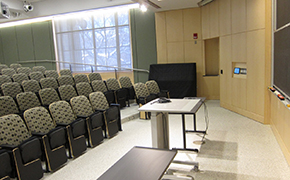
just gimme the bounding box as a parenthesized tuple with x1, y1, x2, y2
(98, 147, 177, 180)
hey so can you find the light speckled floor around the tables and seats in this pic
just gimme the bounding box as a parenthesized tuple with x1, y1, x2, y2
(42, 100, 290, 180)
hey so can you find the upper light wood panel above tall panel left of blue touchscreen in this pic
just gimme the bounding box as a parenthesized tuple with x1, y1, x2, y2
(219, 0, 232, 36)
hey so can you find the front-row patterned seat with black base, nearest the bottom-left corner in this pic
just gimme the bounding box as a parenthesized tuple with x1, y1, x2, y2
(0, 114, 43, 180)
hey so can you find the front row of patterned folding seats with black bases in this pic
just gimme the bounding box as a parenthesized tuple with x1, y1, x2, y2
(0, 92, 122, 180)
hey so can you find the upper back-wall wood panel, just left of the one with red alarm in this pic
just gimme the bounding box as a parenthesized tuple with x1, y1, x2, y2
(165, 10, 183, 42)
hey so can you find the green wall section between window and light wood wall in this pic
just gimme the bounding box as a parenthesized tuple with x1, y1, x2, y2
(130, 9, 157, 82)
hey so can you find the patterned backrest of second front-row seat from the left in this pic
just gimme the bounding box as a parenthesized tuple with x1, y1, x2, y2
(23, 107, 56, 134)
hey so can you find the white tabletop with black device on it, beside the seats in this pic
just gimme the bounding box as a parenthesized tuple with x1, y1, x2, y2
(138, 98, 202, 113)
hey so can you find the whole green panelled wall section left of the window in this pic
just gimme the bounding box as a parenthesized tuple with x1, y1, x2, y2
(0, 21, 56, 69)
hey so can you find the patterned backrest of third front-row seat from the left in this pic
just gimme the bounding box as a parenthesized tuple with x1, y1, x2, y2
(49, 101, 76, 124)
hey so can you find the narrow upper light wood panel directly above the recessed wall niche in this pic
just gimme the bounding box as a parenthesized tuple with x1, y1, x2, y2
(209, 1, 219, 38)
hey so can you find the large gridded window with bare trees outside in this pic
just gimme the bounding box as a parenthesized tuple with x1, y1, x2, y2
(54, 9, 132, 72)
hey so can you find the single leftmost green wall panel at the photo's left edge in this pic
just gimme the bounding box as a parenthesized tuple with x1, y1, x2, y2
(1, 27, 18, 65)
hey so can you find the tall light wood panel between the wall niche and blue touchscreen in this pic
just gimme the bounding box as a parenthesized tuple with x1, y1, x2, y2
(220, 36, 232, 105)
